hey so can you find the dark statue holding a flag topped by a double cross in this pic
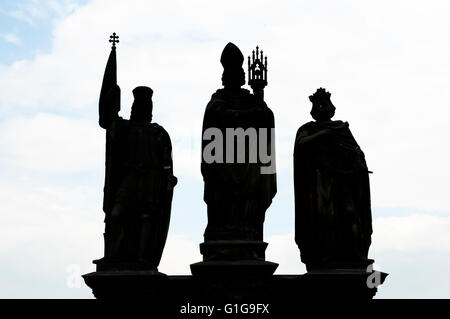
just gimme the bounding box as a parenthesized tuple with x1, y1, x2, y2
(96, 33, 177, 270)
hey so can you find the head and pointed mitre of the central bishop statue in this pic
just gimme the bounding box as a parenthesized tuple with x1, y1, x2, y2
(220, 42, 245, 89)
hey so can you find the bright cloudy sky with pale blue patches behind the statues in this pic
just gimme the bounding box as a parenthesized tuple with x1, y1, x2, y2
(0, 0, 450, 298)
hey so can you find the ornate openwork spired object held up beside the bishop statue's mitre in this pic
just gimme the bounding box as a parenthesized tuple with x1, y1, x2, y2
(248, 46, 267, 99)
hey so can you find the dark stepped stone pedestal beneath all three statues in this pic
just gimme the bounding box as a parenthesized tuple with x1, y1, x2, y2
(83, 246, 387, 319)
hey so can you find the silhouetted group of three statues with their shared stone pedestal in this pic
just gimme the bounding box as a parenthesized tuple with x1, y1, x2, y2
(83, 34, 387, 302)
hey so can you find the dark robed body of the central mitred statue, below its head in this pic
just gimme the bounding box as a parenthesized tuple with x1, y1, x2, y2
(201, 89, 276, 242)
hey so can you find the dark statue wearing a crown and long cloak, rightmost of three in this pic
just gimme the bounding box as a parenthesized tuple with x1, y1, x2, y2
(294, 88, 373, 271)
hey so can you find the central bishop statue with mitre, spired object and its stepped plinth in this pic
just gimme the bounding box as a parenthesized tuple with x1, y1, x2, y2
(191, 43, 278, 275)
